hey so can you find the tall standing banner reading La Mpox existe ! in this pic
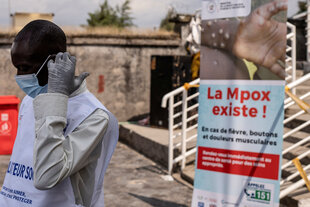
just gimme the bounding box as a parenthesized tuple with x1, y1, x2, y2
(192, 0, 286, 207)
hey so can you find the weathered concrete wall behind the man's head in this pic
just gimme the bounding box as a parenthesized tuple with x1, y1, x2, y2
(0, 33, 184, 121)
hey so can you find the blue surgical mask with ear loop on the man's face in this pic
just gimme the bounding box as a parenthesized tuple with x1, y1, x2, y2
(15, 55, 50, 98)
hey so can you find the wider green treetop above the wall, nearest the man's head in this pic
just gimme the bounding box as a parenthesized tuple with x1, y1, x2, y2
(87, 0, 133, 28)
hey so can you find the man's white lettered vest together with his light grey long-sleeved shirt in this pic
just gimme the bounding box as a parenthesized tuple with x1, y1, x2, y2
(0, 83, 118, 207)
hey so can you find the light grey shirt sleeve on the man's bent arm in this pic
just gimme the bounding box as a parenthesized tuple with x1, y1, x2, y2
(33, 93, 109, 190)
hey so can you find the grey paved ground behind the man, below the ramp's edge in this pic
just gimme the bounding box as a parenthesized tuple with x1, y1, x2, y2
(0, 142, 192, 207)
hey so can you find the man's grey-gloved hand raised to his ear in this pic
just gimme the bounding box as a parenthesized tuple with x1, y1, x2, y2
(47, 52, 89, 96)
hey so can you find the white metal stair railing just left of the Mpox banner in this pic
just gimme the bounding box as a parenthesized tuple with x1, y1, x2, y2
(161, 79, 200, 175)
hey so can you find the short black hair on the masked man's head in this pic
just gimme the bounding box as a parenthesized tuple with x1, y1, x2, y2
(14, 20, 67, 54)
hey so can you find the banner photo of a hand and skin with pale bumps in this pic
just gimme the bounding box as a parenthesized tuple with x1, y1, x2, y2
(201, 0, 287, 80)
